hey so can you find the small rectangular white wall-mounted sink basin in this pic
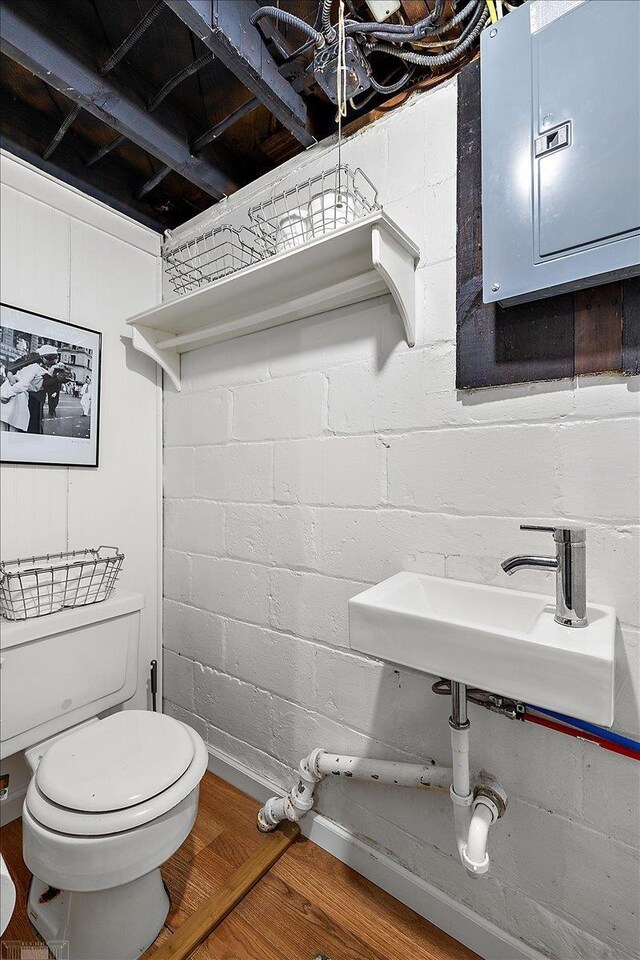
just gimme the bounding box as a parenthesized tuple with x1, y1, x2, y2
(349, 572, 616, 726)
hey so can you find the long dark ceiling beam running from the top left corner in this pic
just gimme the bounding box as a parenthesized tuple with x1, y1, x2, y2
(0, 0, 237, 199)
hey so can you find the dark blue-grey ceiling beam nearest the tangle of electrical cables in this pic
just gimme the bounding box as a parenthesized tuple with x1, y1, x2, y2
(165, 0, 316, 147)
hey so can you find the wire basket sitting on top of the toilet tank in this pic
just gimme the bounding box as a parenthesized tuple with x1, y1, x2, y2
(0, 546, 124, 620)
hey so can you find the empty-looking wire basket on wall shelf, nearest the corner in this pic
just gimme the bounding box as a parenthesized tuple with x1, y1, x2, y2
(164, 223, 273, 294)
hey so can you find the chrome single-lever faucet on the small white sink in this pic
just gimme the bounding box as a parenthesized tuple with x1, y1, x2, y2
(502, 524, 587, 627)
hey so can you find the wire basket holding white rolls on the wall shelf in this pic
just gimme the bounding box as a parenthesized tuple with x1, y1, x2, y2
(249, 164, 380, 253)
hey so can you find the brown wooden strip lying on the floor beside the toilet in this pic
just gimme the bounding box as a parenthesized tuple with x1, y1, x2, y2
(148, 821, 300, 960)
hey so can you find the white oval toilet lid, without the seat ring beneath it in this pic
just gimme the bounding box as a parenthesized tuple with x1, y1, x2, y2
(36, 710, 194, 812)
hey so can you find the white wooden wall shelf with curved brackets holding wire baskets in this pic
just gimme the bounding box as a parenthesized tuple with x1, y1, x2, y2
(127, 211, 420, 390)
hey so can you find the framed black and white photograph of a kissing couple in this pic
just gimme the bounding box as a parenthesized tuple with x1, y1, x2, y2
(0, 304, 102, 467)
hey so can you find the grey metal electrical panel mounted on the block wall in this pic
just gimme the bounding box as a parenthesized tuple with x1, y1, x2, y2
(481, 0, 640, 304)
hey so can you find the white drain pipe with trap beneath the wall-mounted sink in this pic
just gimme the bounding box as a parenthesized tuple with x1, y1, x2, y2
(258, 682, 507, 876)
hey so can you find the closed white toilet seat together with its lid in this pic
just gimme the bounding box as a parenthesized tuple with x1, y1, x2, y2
(25, 710, 208, 837)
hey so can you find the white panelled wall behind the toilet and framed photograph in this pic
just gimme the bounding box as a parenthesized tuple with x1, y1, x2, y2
(0, 151, 162, 720)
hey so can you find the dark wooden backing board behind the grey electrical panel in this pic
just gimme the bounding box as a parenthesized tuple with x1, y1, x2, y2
(456, 62, 640, 390)
